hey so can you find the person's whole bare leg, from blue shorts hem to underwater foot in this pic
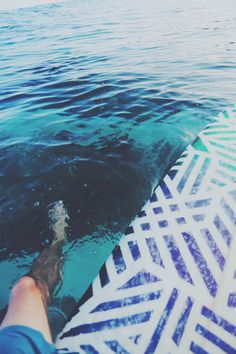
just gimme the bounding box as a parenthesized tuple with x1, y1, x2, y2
(0, 202, 68, 342)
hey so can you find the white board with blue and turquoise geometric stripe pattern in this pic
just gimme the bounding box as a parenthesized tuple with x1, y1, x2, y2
(56, 108, 236, 354)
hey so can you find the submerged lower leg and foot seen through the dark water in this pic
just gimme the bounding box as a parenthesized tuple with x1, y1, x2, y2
(28, 201, 69, 307)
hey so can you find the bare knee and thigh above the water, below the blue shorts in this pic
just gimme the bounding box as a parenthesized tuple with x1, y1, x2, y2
(0, 276, 52, 343)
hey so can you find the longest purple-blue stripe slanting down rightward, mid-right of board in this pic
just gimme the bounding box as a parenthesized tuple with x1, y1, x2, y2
(182, 232, 218, 296)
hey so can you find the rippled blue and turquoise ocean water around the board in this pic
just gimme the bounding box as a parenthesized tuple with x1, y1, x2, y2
(0, 0, 236, 332)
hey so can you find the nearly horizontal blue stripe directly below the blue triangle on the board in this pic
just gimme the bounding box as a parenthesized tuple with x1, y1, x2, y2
(91, 290, 161, 313)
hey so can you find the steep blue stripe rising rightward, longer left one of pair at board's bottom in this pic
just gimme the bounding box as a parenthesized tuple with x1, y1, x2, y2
(145, 288, 178, 354)
